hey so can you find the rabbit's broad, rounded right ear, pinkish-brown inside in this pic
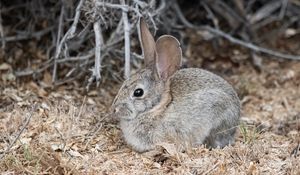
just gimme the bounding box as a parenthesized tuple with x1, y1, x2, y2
(156, 35, 182, 80)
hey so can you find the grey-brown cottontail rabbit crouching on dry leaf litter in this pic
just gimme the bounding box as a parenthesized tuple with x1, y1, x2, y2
(111, 19, 240, 152)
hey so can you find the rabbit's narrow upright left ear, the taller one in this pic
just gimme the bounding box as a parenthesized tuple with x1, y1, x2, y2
(140, 18, 156, 67)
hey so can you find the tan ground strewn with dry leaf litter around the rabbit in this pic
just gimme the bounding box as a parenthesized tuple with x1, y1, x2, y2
(0, 51, 300, 174)
